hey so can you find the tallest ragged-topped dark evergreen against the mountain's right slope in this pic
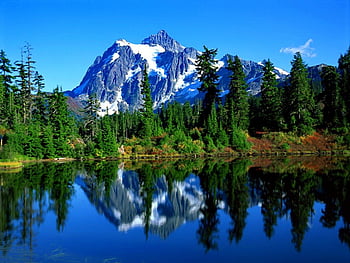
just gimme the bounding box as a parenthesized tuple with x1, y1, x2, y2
(196, 46, 220, 125)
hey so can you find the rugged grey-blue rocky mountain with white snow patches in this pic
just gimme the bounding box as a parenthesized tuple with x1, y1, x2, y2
(66, 30, 288, 115)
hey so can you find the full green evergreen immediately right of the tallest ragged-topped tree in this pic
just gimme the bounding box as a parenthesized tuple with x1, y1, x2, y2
(226, 56, 249, 130)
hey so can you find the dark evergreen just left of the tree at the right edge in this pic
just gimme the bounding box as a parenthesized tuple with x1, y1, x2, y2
(321, 66, 344, 128)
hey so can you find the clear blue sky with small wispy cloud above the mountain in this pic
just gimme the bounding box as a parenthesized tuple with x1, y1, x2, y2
(0, 0, 350, 90)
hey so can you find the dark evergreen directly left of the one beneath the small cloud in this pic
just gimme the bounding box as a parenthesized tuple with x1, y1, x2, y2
(261, 60, 282, 131)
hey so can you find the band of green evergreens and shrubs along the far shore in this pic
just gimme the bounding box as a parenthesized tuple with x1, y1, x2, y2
(0, 44, 350, 159)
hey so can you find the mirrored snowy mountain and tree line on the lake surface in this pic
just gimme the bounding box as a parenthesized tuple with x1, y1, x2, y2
(0, 157, 350, 254)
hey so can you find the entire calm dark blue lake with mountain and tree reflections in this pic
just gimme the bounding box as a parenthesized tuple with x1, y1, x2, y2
(0, 157, 350, 263)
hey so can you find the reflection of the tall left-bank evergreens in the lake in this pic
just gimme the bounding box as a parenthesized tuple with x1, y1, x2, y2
(0, 163, 76, 254)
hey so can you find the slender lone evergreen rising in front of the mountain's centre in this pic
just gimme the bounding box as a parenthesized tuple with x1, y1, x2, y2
(141, 65, 154, 139)
